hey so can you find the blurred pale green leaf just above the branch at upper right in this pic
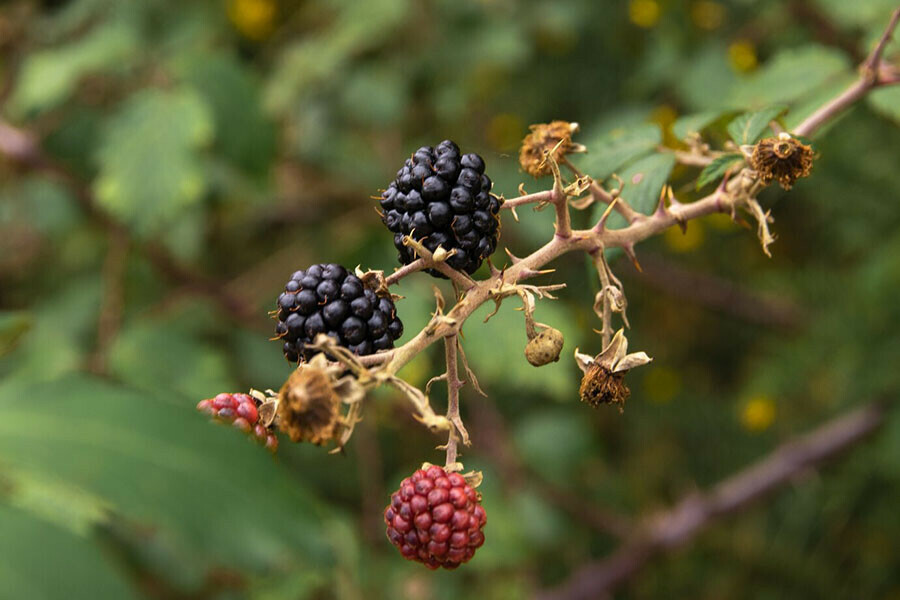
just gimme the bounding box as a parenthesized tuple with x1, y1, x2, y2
(728, 45, 850, 107)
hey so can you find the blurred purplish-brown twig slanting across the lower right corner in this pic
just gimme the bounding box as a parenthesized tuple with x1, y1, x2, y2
(538, 403, 886, 600)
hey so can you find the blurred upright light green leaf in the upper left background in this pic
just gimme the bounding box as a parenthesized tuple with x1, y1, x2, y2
(94, 89, 213, 234)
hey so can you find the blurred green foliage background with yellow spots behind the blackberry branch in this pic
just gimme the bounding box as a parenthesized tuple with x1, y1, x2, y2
(0, 0, 900, 600)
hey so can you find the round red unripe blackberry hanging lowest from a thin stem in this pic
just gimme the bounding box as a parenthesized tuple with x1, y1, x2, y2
(384, 465, 487, 569)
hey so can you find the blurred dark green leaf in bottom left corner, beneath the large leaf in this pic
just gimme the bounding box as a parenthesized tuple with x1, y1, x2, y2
(0, 502, 138, 600)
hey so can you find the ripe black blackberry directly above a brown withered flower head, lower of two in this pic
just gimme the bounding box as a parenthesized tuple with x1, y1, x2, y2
(275, 264, 403, 362)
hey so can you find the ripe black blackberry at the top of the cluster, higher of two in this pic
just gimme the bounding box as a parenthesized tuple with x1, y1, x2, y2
(380, 140, 500, 277)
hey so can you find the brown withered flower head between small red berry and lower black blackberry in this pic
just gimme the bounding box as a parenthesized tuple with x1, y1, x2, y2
(278, 365, 341, 445)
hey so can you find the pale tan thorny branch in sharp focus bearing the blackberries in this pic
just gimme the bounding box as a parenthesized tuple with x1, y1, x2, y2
(373, 9, 900, 462)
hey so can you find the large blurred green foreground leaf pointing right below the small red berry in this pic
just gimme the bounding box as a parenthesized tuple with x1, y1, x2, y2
(0, 377, 329, 572)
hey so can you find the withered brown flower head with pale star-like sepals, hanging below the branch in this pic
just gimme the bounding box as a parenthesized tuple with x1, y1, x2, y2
(575, 329, 653, 412)
